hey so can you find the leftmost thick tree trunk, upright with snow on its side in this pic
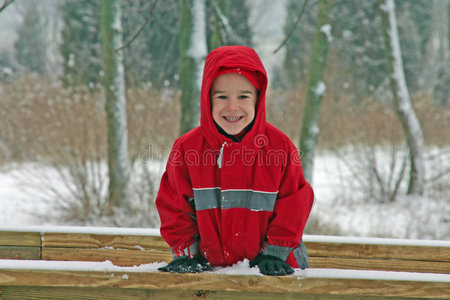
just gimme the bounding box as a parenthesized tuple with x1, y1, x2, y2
(101, 0, 130, 214)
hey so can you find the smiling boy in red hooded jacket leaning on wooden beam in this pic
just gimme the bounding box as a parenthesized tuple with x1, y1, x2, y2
(156, 46, 314, 275)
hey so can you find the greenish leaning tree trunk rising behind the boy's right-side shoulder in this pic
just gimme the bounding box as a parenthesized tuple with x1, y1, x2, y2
(300, 0, 334, 182)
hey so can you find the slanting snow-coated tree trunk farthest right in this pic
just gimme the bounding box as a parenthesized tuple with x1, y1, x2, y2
(380, 0, 425, 195)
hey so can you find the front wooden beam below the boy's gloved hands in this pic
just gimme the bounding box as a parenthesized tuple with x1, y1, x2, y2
(0, 270, 450, 299)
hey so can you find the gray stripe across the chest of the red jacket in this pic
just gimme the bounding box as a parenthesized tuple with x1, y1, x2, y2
(194, 188, 277, 211)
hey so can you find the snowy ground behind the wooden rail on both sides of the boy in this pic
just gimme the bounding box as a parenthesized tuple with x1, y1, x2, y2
(0, 149, 450, 240)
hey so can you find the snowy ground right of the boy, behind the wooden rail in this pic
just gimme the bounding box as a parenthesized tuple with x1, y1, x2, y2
(310, 147, 450, 240)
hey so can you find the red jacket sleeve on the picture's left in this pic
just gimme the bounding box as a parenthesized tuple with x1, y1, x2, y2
(155, 141, 198, 258)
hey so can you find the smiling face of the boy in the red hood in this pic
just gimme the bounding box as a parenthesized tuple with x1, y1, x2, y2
(210, 73, 258, 135)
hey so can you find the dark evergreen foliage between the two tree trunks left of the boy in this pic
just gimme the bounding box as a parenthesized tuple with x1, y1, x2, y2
(122, 0, 180, 89)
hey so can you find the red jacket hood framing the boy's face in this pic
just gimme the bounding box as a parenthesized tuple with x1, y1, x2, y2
(200, 46, 267, 147)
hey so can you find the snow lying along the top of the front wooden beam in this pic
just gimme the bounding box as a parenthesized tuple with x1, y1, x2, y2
(0, 259, 450, 283)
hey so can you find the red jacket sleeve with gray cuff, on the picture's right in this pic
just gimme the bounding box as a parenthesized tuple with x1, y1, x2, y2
(262, 140, 314, 260)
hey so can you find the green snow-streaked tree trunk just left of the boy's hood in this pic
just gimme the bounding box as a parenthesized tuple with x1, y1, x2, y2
(180, 0, 207, 134)
